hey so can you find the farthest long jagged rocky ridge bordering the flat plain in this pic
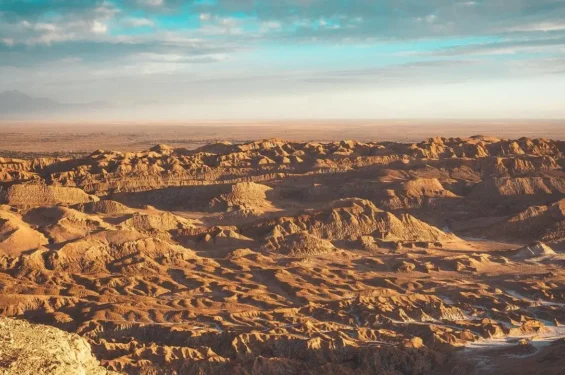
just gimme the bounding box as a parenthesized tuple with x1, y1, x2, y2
(0, 137, 565, 199)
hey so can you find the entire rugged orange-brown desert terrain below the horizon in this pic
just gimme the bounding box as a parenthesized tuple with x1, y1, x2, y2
(0, 122, 565, 375)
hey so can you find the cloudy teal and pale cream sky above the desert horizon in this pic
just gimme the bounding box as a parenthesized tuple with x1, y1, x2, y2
(0, 0, 565, 120)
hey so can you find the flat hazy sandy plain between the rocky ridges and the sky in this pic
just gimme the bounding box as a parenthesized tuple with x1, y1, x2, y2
(0, 120, 565, 154)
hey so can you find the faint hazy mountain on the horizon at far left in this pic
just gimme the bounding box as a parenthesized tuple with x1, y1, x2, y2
(0, 90, 111, 115)
